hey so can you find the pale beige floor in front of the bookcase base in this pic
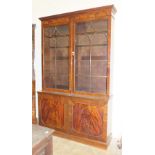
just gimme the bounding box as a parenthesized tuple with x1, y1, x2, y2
(53, 136, 122, 155)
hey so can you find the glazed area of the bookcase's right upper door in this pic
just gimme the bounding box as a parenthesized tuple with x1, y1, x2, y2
(75, 20, 108, 93)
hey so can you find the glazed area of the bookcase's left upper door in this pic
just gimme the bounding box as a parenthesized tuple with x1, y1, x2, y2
(43, 25, 69, 89)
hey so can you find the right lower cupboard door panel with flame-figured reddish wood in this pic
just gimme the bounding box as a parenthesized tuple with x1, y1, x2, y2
(72, 102, 103, 139)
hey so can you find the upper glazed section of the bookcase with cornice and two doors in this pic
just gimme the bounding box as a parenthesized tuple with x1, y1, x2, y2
(40, 5, 116, 95)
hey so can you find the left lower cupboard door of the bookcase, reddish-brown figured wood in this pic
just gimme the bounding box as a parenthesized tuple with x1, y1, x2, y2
(39, 95, 64, 129)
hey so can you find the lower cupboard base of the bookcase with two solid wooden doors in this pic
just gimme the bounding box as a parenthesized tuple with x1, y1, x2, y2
(38, 92, 111, 148)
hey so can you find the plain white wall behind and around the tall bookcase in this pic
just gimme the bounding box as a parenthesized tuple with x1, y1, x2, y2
(32, 0, 123, 137)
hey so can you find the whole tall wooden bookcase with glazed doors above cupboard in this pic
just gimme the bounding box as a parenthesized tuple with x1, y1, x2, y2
(38, 5, 116, 148)
